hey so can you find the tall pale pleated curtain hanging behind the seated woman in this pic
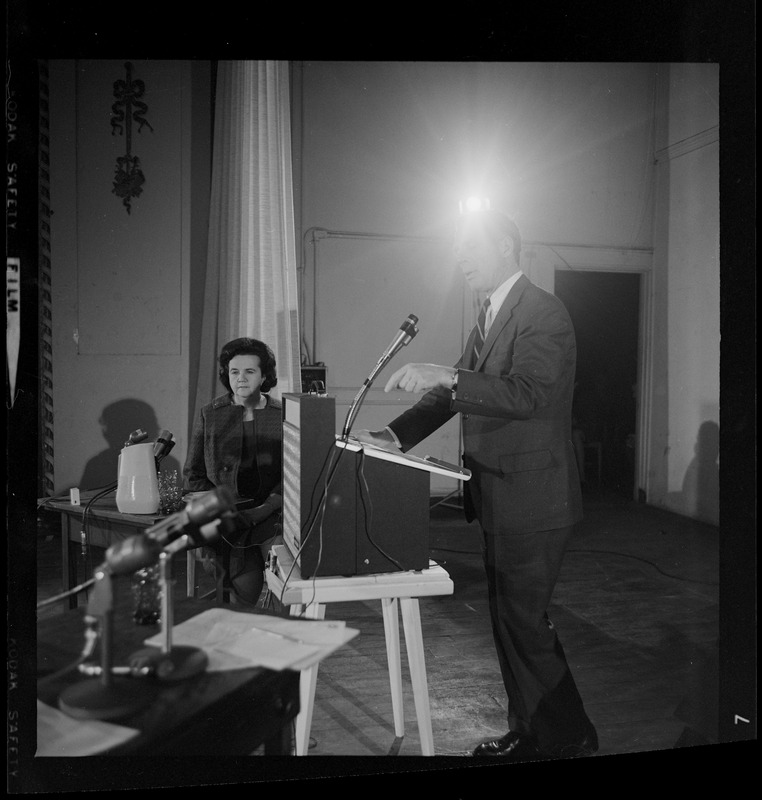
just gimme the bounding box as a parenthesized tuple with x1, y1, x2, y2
(195, 61, 301, 412)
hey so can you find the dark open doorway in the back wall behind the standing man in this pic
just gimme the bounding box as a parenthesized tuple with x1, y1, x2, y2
(555, 270, 640, 499)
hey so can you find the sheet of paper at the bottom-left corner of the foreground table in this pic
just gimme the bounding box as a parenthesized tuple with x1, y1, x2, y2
(35, 700, 138, 757)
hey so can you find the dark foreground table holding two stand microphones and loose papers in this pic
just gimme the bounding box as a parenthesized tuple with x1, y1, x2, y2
(37, 578, 299, 757)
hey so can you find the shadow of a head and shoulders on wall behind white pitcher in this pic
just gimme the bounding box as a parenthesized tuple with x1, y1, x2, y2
(79, 398, 180, 491)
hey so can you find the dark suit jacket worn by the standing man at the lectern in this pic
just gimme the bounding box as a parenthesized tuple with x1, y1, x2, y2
(389, 275, 582, 534)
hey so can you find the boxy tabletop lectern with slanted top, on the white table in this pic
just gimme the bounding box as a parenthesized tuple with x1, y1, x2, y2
(283, 394, 470, 578)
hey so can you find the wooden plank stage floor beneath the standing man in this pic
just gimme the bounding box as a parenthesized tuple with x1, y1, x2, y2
(37, 484, 719, 757)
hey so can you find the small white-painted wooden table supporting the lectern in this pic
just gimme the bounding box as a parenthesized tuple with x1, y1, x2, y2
(265, 545, 454, 756)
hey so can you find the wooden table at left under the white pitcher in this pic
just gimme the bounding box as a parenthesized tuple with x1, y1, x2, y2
(38, 490, 166, 608)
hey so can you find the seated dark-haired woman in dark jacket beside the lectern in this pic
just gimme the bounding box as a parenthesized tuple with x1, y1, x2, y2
(183, 338, 283, 605)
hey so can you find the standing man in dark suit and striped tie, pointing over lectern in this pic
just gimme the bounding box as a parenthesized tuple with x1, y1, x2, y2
(357, 211, 598, 761)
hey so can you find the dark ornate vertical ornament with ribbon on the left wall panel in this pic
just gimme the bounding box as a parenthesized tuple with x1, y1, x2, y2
(111, 61, 153, 214)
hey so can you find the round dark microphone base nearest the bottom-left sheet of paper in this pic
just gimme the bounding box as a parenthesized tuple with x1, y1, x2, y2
(58, 678, 155, 719)
